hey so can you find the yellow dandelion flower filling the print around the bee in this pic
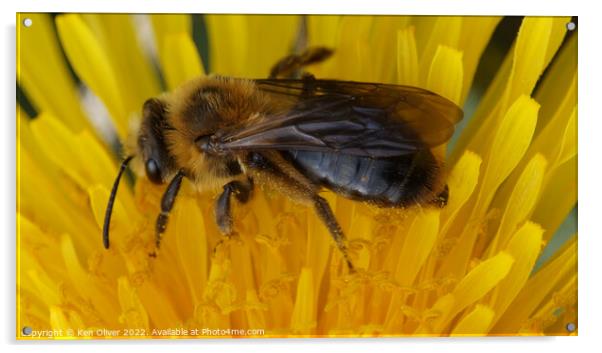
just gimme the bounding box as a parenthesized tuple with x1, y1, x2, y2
(17, 14, 577, 339)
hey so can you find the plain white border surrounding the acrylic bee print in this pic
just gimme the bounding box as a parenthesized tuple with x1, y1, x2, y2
(0, 0, 602, 353)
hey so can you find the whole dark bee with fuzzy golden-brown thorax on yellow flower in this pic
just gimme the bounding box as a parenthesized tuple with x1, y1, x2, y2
(103, 48, 463, 271)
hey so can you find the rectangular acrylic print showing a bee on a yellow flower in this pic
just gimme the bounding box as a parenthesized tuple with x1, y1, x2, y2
(16, 13, 578, 339)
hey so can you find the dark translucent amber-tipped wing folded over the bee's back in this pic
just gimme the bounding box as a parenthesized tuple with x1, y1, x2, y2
(213, 79, 463, 158)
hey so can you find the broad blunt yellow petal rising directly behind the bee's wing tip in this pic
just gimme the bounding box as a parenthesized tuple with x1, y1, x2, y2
(426, 45, 464, 105)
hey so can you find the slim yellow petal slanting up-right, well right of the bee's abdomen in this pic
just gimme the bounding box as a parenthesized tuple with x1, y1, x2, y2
(490, 154, 547, 253)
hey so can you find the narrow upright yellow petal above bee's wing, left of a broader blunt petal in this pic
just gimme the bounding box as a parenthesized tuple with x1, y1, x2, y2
(397, 26, 418, 86)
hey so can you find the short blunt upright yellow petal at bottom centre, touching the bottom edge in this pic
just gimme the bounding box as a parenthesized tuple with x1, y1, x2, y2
(291, 267, 317, 334)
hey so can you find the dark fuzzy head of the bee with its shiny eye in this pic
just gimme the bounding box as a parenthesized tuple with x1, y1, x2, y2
(136, 98, 176, 184)
